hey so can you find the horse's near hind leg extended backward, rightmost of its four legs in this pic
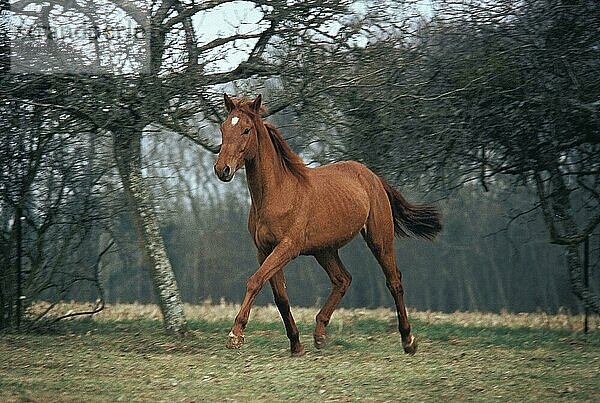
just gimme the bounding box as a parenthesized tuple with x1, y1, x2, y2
(363, 219, 417, 355)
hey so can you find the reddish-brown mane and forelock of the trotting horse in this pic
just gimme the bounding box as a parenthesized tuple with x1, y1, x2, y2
(233, 98, 308, 181)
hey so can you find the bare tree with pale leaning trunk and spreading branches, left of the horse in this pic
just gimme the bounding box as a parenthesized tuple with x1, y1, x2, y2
(3, 0, 358, 334)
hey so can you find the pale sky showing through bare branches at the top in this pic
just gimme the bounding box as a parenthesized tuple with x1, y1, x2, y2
(11, 0, 432, 73)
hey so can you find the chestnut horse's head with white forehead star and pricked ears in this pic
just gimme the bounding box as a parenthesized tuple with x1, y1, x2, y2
(215, 94, 262, 182)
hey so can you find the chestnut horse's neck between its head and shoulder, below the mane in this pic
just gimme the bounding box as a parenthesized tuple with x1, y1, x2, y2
(246, 125, 291, 209)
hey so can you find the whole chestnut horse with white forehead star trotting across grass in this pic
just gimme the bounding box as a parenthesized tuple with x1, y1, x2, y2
(214, 94, 441, 356)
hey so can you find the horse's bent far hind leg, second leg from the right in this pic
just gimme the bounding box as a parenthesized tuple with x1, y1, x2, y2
(314, 250, 352, 348)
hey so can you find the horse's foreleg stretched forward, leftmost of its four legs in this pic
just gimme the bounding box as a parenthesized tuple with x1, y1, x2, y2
(227, 240, 299, 348)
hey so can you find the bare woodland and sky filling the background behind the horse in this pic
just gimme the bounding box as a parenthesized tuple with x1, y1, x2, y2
(0, 0, 600, 327)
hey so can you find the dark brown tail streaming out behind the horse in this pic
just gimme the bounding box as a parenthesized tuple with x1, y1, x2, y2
(379, 178, 442, 239)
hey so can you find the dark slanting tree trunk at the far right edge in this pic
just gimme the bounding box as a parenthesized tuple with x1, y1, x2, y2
(536, 167, 600, 313)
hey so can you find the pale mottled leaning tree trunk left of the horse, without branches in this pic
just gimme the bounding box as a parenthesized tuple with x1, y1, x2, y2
(113, 130, 187, 335)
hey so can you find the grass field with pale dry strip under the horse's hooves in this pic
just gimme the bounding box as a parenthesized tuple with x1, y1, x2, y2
(0, 305, 600, 402)
